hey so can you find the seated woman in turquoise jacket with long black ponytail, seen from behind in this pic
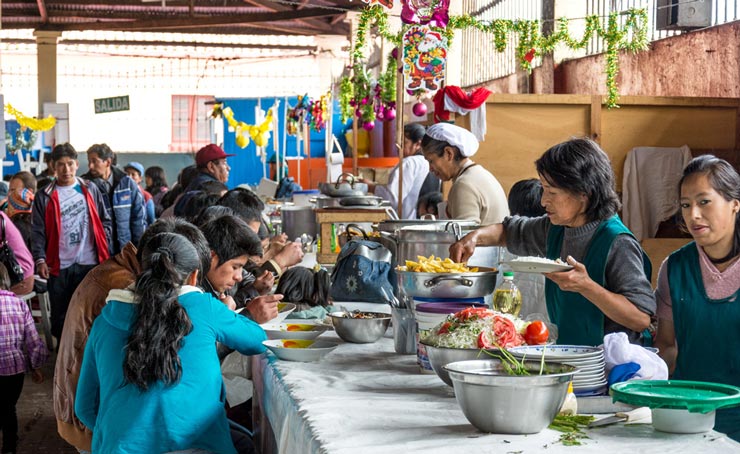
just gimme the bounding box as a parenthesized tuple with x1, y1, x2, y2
(75, 233, 266, 454)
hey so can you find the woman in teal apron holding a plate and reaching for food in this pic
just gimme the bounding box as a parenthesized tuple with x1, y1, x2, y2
(450, 139, 655, 345)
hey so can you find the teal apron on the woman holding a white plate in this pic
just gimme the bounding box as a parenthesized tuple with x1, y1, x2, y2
(545, 215, 651, 345)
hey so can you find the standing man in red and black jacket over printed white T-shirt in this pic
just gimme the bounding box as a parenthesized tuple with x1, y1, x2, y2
(31, 143, 111, 339)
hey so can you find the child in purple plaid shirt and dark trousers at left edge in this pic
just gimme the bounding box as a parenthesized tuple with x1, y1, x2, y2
(0, 263, 49, 453)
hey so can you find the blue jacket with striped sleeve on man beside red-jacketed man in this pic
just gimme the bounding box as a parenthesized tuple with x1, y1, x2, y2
(82, 166, 146, 255)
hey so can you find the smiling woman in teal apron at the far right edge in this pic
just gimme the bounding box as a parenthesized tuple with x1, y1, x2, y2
(655, 155, 740, 441)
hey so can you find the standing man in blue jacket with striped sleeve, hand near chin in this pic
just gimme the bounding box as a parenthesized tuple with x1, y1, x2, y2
(82, 143, 146, 254)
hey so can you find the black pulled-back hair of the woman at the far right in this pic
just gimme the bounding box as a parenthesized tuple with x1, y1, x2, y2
(678, 155, 740, 263)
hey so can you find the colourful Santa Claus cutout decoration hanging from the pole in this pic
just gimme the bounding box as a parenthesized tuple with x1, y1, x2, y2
(403, 26, 447, 95)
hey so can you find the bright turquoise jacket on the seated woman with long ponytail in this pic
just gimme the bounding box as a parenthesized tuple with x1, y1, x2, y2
(75, 286, 266, 454)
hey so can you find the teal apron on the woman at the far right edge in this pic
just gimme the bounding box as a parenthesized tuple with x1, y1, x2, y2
(668, 242, 740, 441)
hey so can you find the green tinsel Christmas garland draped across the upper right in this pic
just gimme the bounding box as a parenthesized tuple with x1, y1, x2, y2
(352, 5, 648, 107)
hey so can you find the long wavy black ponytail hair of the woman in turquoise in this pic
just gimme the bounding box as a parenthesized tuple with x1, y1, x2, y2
(123, 233, 200, 391)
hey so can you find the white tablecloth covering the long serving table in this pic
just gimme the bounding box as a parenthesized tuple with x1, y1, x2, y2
(253, 331, 740, 454)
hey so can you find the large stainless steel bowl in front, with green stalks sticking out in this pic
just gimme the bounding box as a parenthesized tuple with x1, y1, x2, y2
(444, 359, 577, 434)
